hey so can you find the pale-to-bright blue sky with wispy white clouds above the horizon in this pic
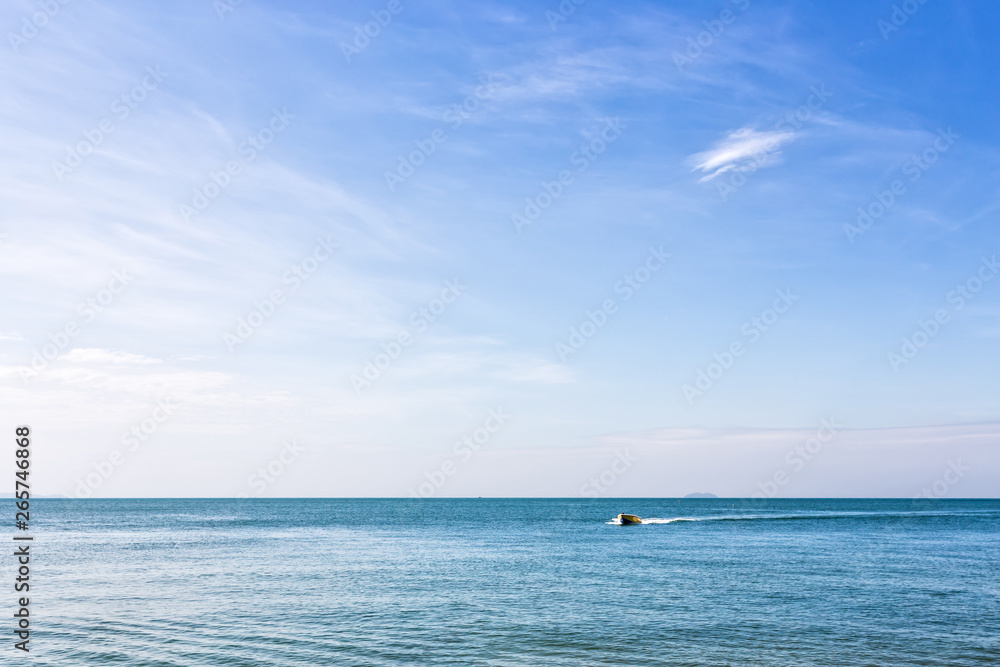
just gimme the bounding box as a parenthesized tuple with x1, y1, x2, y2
(0, 0, 1000, 497)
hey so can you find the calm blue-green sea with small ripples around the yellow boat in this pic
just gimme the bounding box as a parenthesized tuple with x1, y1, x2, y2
(15, 498, 1000, 667)
